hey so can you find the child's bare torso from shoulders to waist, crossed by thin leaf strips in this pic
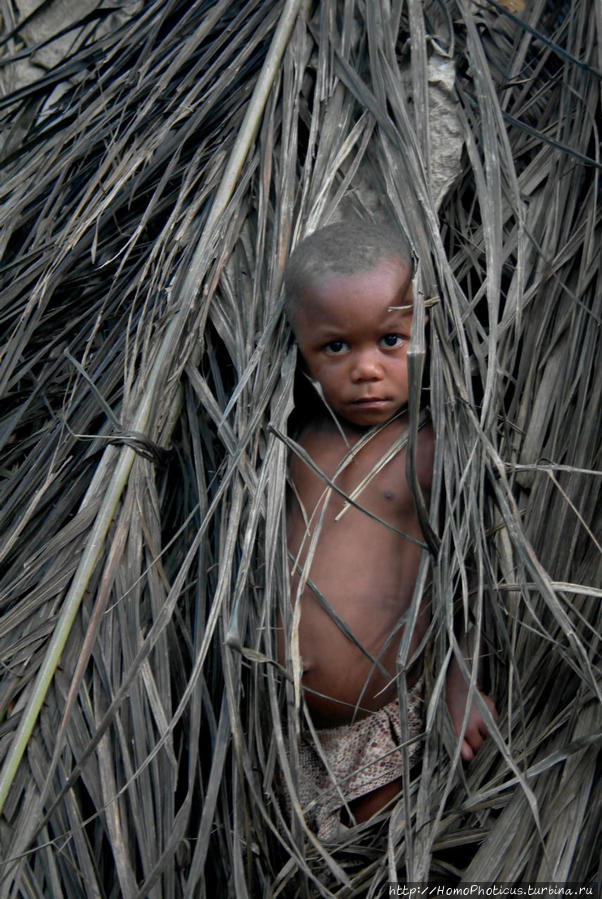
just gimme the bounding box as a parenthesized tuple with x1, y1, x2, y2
(287, 421, 426, 726)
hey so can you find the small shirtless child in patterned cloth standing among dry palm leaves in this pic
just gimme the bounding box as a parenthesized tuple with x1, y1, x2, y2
(285, 221, 494, 838)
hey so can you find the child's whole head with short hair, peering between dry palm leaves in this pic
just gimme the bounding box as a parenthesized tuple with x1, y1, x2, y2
(285, 222, 413, 427)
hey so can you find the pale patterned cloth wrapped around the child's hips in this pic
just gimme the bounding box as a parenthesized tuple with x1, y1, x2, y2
(299, 678, 423, 840)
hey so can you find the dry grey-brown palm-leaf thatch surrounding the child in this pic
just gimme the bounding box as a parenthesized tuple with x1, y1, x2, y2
(0, 0, 602, 899)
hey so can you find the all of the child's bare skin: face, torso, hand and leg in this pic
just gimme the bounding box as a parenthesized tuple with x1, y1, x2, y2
(287, 258, 487, 821)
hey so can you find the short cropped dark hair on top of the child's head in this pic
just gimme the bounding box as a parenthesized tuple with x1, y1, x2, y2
(284, 219, 414, 323)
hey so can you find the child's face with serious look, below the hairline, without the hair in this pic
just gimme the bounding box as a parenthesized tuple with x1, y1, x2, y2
(294, 258, 412, 428)
